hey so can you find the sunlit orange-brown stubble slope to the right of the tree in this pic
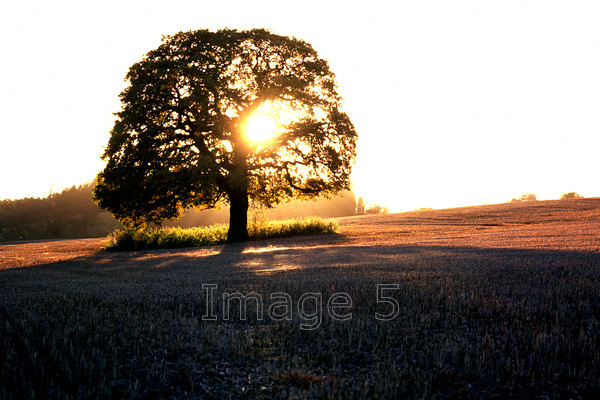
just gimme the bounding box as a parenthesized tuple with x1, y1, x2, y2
(339, 198, 600, 251)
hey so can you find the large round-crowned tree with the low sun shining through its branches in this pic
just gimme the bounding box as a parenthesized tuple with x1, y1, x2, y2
(94, 29, 357, 241)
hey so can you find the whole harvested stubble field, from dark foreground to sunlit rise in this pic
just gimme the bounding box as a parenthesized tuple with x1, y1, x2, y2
(0, 199, 600, 399)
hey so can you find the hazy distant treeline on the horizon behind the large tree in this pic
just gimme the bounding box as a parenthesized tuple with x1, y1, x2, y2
(0, 182, 364, 241)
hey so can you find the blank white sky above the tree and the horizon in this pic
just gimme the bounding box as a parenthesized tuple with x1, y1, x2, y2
(0, 0, 600, 211)
